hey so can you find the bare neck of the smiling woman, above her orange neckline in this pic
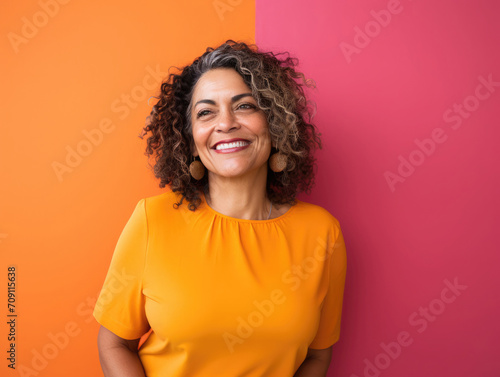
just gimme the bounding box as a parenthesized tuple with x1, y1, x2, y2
(205, 166, 272, 220)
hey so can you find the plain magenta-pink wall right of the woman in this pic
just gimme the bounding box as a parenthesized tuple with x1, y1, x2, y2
(256, 0, 500, 377)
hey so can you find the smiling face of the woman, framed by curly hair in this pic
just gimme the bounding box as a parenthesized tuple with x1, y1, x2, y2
(191, 68, 271, 178)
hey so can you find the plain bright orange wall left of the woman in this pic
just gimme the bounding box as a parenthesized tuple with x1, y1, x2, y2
(0, 0, 255, 377)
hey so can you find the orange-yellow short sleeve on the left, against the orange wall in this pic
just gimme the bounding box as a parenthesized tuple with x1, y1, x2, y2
(93, 199, 150, 339)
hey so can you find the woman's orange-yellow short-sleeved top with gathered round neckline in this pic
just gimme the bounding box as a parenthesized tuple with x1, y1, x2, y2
(94, 191, 346, 377)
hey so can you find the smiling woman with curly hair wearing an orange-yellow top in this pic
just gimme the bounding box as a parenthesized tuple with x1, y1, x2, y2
(94, 40, 346, 377)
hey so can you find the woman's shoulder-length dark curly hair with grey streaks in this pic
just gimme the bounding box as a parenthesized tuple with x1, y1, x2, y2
(139, 39, 322, 211)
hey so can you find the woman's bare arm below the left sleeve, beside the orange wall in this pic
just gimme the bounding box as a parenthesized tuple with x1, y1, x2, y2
(97, 326, 146, 377)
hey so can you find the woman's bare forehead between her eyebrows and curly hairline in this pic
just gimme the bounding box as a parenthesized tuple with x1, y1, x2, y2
(193, 68, 251, 99)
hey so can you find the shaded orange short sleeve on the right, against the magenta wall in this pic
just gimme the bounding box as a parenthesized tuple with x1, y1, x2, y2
(309, 221, 347, 349)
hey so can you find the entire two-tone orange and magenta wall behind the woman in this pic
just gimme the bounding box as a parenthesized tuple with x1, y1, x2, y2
(0, 0, 500, 377)
